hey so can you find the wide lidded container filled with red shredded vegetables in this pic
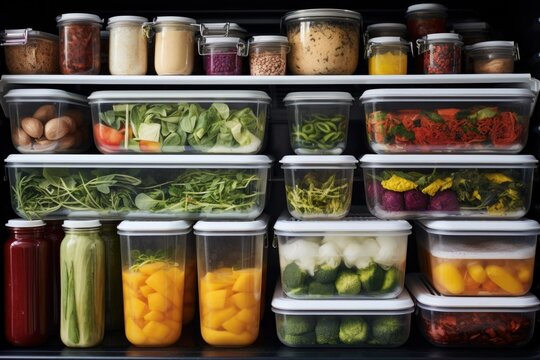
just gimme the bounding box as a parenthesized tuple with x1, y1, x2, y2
(360, 88, 534, 154)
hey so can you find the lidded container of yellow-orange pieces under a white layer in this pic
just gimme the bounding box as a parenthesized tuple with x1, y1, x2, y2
(416, 219, 540, 296)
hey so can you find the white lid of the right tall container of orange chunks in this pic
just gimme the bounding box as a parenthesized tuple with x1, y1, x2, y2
(193, 214, 269, 236)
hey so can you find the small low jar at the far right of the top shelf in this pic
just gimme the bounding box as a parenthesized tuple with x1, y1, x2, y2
(468, 41, 519, 74)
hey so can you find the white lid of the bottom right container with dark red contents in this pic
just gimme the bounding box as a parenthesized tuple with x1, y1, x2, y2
(405, 274, 540, 312)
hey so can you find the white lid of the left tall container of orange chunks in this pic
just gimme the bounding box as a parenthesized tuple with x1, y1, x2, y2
(117, 220, 192, 236)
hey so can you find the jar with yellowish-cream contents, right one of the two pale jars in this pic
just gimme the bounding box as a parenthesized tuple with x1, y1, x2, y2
(153, 16, 196, 75)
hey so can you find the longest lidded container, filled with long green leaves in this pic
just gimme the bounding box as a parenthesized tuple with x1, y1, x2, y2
(6, 154, 272, 220)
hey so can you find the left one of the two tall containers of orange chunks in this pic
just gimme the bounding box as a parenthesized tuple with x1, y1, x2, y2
(118, 221, 191, 346)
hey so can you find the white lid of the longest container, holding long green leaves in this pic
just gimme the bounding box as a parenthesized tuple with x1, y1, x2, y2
(5, 154, 272, 169)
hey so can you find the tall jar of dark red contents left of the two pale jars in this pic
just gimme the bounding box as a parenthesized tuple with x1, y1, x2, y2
(56, 13, 103, 75)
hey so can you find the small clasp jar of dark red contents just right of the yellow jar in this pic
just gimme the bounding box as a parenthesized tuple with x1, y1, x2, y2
(416, 33, 463, 74)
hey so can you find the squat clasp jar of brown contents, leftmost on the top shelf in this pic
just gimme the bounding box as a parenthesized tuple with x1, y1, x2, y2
(0, 29, 60, 74)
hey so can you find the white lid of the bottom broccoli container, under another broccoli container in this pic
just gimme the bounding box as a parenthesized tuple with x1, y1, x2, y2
(272, 281, 414, 315)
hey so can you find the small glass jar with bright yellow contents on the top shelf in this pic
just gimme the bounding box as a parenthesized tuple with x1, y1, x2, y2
(366, 36, 410, 75)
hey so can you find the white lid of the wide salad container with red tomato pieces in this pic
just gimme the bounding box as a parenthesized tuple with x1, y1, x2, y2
(88, 90, 271, 104)
